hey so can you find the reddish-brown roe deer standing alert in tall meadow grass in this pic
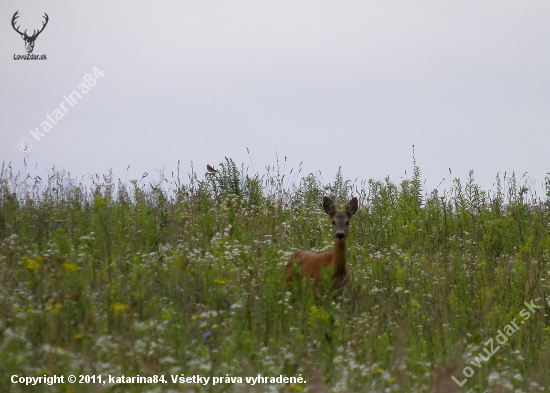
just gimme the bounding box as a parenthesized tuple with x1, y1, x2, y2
(285, 196, 357, 291)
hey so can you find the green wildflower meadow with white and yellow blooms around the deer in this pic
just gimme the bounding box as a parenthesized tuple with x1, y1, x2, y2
(0, 158, 550, 393)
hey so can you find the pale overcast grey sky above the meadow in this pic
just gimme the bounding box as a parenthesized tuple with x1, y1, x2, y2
(0, 0, 550, 195)
